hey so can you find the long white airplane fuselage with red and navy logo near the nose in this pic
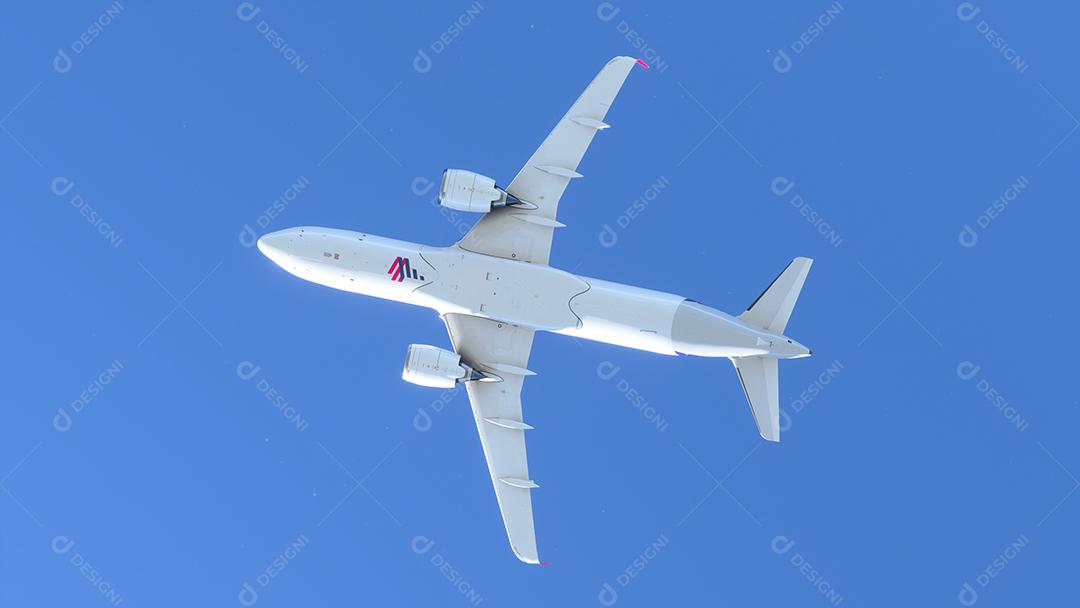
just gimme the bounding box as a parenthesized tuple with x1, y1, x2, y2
(258, 227, 810, 359)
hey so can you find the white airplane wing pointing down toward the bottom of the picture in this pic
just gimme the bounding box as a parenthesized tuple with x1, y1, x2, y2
(443, 313, 540, 564)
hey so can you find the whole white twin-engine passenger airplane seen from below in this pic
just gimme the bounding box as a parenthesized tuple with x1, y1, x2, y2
(258, 56, 812, 564)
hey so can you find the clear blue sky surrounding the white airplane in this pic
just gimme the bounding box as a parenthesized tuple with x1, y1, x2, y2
(0, 0, 1080, 608)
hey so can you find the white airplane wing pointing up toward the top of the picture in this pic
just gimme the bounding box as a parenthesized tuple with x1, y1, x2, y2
(458, 57, 648, 265)
